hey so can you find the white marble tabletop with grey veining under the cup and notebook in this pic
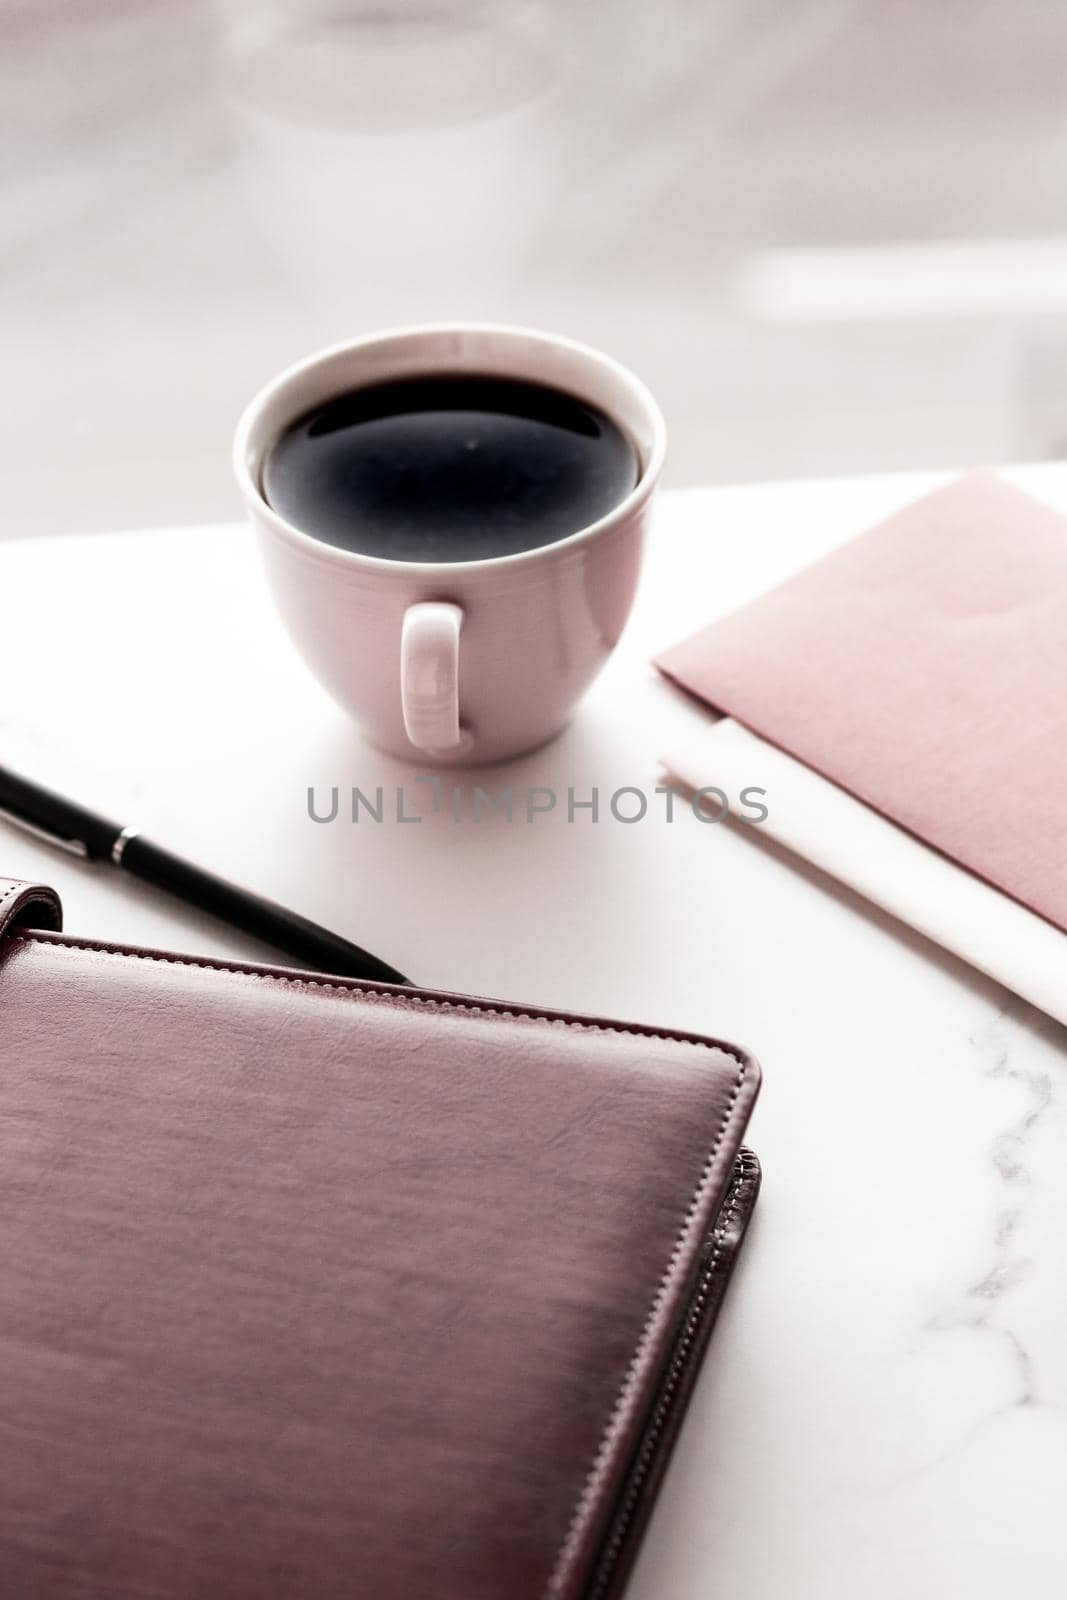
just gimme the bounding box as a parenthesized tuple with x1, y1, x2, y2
(0, 469, 1067, 1600)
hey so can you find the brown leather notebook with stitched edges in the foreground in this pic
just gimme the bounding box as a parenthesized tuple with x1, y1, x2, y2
(0, 880, 758, 1600)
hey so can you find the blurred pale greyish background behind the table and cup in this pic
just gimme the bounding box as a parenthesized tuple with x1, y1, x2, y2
(0, 0, 1067, 536)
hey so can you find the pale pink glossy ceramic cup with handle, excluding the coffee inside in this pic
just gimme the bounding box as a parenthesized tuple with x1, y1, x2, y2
(234, 323, 665, 766)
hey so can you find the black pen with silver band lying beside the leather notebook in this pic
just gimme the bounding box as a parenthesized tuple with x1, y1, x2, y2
(0, 766, 408, 984)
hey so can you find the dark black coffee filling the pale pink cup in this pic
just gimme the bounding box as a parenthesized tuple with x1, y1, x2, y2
(262, 373, 638, 562)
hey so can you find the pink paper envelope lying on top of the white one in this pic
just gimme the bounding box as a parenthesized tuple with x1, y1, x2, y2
(657, 474, 1067, 934)
